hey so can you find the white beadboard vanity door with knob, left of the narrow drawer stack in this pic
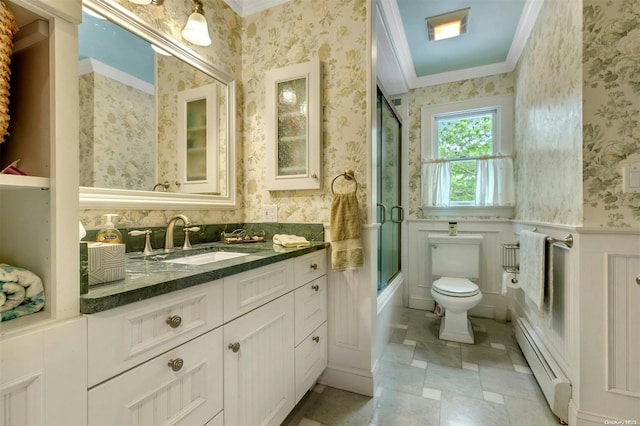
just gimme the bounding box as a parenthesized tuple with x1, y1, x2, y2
(224, 293, 295, 426)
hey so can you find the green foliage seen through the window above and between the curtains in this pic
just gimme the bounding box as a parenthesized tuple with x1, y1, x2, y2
(437, 113, 493, 202)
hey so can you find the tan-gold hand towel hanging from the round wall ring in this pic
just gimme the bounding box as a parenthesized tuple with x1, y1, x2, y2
(331, 192, 364, 271)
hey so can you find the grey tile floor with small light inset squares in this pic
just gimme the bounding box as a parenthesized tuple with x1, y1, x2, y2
(283, 308, 559, 426)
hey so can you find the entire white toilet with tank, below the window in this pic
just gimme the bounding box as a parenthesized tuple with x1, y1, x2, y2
(429, 234, 482, 343)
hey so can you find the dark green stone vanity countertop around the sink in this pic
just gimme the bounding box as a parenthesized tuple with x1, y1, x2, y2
(80, 241, 329, 314)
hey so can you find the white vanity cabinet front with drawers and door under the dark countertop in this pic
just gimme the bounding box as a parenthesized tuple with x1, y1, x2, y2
(87, 250, 327, 426)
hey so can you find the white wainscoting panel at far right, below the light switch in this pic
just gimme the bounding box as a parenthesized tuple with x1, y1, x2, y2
(572, 229, 640, 424)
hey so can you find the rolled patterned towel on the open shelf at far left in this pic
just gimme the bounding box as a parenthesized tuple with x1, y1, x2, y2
(0, 263, 44, 321)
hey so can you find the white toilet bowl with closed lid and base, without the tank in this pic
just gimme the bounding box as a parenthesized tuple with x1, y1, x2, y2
(431, 277, 482, 344)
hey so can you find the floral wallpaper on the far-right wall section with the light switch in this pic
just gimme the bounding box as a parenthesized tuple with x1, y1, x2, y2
(582, 0, 640, 229)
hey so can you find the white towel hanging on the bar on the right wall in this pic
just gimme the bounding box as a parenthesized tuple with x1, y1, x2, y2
(519, 231, 547, 309)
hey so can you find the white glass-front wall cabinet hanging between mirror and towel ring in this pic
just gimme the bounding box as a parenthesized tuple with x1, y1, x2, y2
(266, 58, 322, 190)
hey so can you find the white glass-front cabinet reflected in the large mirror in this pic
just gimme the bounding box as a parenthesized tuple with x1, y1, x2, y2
(177, 84, 220, 194)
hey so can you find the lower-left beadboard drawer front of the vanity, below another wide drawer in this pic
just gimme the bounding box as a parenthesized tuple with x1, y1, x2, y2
(89, 328, 222, 426)
